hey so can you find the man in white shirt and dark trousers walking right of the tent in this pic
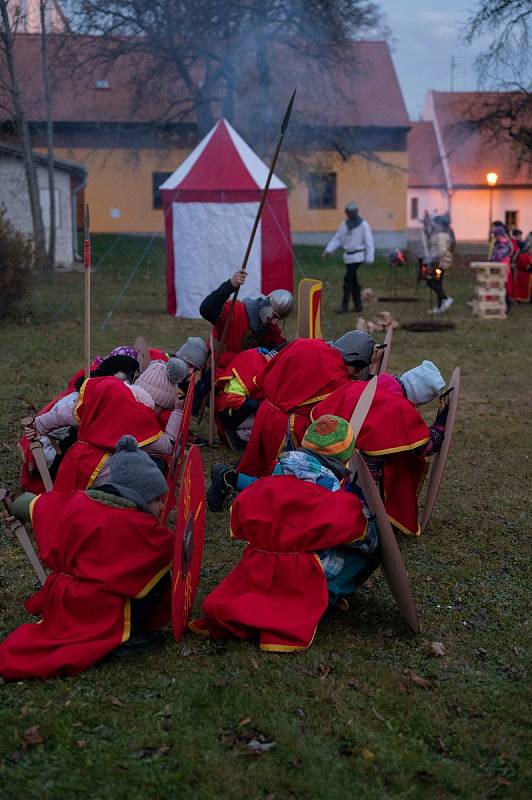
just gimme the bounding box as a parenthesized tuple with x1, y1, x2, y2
(321, 202, 375, 314)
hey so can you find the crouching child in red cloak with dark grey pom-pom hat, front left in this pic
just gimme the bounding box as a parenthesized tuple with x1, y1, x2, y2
(0, 436, 174, 680)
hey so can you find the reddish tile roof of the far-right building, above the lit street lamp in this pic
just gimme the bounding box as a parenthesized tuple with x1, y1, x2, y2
(432, 92, 532, 187)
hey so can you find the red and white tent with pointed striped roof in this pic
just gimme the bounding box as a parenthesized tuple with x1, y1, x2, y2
(160, 119, 293, 318)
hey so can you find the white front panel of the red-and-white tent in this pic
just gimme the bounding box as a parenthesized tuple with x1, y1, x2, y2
(172, 203, 262, 319)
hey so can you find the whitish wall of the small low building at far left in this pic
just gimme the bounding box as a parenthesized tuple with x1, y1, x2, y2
(0, 156, 73, 268)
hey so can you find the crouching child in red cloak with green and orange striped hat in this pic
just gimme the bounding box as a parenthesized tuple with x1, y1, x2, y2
(190, 415, 379, 652)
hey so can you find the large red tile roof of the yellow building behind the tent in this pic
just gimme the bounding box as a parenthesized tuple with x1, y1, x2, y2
(0, 34, 409, 127)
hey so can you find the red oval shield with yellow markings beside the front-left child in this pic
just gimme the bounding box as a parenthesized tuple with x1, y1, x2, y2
(172, 445, 205, 642)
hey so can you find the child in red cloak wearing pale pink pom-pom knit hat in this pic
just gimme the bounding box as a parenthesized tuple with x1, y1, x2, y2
(34, 359, 188, 492)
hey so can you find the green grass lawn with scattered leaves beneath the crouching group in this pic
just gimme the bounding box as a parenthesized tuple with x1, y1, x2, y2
(0, 236, 532, 800)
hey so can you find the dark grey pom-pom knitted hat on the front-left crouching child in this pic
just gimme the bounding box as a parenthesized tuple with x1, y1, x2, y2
(109, 436, 168, 511)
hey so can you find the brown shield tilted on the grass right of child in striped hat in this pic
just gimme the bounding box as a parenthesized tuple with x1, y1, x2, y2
(351, 451, 419, 633)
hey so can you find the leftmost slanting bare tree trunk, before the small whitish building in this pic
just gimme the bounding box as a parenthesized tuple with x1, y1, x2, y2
(0, 0, 46, 268)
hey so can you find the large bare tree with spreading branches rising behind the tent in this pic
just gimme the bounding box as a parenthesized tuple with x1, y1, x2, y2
(70, 0, 383, 158)
